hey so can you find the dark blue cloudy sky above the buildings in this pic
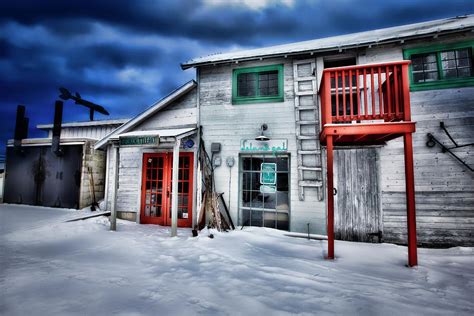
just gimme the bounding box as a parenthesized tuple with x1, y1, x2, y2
(0, 0, 474, 159)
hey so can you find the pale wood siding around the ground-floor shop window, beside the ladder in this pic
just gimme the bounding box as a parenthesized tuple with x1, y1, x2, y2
(198, 58, 326, 234)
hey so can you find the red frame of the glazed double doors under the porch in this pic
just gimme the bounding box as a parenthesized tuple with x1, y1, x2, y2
(140, 152, 194, 227)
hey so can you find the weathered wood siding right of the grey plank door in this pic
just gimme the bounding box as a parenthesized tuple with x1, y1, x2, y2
(365, 37, 474, 246)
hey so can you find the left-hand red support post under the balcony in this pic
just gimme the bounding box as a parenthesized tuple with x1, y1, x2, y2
(326, 135, 334, 259)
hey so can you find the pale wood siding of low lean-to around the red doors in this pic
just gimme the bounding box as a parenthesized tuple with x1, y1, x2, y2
(106, 89, 197, 219)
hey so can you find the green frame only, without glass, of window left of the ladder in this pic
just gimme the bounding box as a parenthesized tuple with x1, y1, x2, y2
(232, 64, 284, 104)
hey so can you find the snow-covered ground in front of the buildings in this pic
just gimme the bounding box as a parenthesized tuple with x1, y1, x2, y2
(0, 205, 474, 315)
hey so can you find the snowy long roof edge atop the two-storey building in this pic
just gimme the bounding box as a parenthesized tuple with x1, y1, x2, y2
(181, 15, 474, 69)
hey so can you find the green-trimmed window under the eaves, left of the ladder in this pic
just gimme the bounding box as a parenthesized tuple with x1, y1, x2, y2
(232, 65, 283, 104)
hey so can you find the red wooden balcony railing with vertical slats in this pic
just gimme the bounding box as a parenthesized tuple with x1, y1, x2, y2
(319, 61, 411, 126)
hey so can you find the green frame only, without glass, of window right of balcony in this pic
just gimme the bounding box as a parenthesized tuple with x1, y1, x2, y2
(403, 41, 474, 91)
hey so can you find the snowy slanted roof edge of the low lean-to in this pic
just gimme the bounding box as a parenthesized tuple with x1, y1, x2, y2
(94, 80, 197, 149)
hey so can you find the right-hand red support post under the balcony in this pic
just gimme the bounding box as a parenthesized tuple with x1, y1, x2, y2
(404, 133, 418, 267)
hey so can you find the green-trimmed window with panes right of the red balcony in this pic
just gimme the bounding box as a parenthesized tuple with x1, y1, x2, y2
(403, 41, 474, 91)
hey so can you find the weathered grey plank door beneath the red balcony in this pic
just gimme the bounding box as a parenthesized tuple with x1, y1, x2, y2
(334, 148, 382, 241)
